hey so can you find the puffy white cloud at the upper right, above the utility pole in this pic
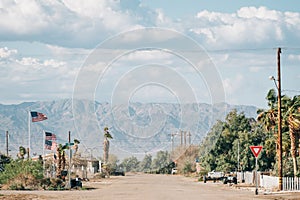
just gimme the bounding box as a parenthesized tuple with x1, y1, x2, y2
(190, 7, 300, 48)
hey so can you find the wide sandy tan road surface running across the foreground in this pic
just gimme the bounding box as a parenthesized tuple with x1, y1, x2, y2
(0, 174, 300, 200)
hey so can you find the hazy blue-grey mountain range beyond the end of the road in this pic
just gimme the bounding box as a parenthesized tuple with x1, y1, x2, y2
(0, 99, 257, 157)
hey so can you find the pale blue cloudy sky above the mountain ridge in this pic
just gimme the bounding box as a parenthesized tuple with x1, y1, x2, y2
(0, 0, 300, 107)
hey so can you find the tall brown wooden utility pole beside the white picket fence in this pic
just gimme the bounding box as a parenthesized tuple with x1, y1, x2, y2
(277, 48, 282, 190)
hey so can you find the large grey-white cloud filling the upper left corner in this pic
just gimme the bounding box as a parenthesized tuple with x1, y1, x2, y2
(0, 0, 162, 47)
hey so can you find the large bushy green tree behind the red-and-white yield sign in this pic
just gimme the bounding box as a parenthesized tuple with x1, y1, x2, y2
(200, 110, 274, 172)
